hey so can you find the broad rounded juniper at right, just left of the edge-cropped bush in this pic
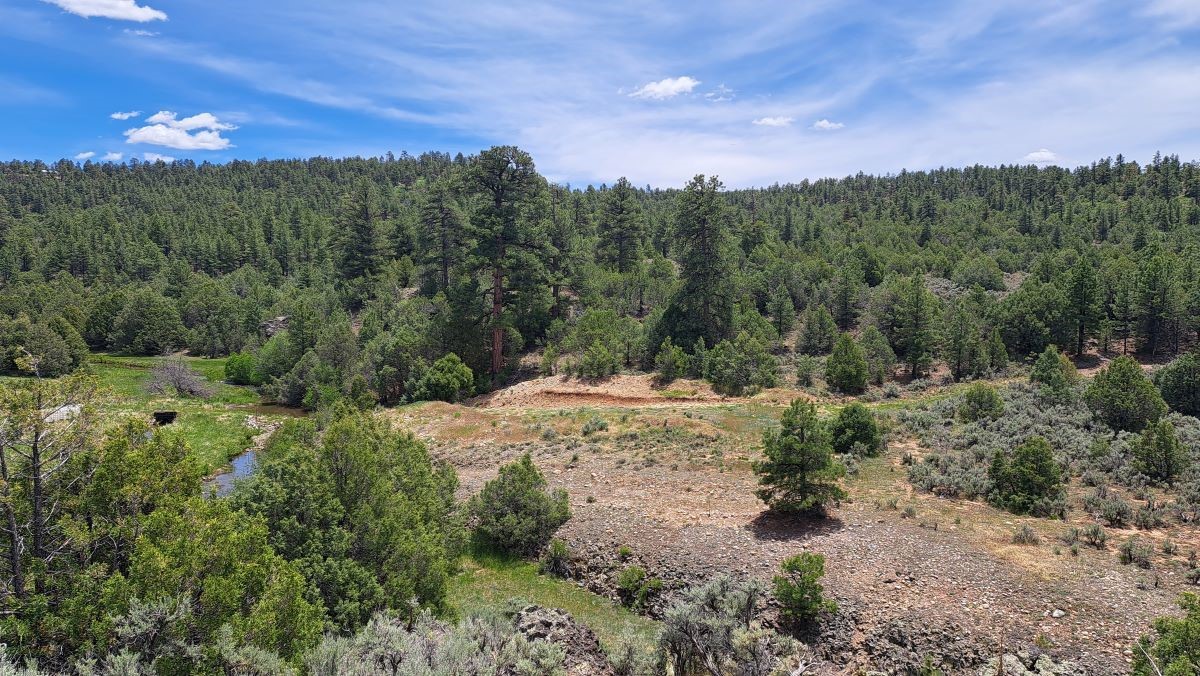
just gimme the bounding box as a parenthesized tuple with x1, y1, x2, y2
(1084, 357, 1166, 432)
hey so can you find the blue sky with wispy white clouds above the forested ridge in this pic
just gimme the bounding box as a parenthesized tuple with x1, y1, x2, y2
(0, 0, 1200, 186)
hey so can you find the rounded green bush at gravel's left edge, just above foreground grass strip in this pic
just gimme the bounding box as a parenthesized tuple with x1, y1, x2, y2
(468, 453, 571, 555)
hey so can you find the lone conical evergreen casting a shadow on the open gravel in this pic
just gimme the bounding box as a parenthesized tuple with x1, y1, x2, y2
(754, 400, 846, 513)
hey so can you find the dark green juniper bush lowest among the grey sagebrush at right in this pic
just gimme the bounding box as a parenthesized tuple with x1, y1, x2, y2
(988, 437, 1063, 514)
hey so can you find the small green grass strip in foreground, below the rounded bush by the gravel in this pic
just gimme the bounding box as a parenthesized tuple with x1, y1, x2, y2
(450, 555, 659, 652)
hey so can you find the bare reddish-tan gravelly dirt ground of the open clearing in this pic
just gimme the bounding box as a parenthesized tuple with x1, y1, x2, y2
(386, 376, 1180, 674)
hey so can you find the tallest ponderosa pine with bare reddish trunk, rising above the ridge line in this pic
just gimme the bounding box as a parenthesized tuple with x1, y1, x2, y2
(470, 145, 542, 385)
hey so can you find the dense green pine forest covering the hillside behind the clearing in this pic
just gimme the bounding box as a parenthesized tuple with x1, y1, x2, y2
(0, 148, 1200, 407)
